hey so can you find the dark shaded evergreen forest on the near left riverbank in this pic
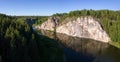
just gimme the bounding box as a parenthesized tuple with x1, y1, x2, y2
(0, 14, 63, 62)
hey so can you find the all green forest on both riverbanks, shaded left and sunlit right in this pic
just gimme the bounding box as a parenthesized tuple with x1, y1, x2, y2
(0, 9, 120, 62)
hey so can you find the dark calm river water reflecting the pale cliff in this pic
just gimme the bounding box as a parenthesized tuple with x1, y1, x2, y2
(39, 30, 120, 62)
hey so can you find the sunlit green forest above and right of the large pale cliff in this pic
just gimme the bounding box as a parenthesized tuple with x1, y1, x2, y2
(52, 9, 120, 42)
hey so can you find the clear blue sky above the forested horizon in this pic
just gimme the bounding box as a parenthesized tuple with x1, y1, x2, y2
(0, 0, 120, 16)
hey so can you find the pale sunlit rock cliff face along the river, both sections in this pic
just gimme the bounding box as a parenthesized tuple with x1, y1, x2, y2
(35, 17, 110, 42)
